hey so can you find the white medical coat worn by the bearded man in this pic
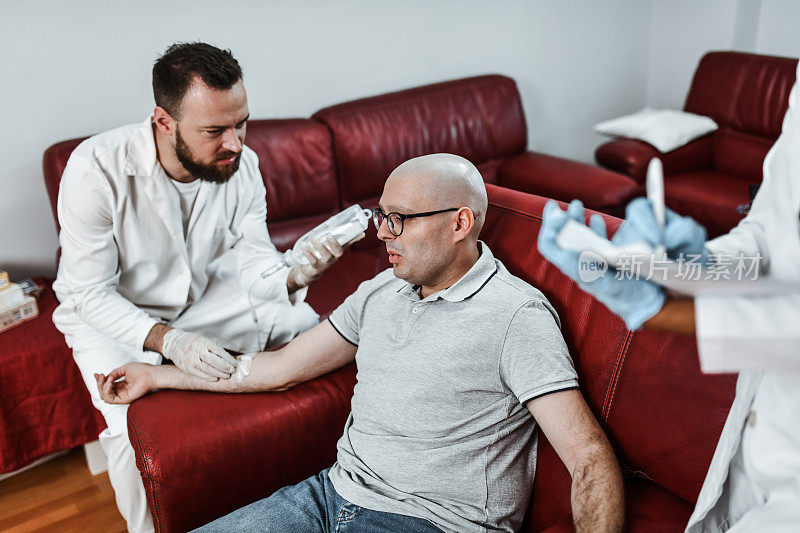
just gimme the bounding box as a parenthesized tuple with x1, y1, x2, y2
(53, 119, 306, 362)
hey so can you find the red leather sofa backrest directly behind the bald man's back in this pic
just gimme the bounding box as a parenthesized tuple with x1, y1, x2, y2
(481, 185, 735, 527)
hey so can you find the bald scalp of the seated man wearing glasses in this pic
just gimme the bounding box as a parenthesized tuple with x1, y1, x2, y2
(387, 154, 488, 238)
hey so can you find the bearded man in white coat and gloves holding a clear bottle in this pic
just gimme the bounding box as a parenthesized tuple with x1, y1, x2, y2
(53, 43, 350, 531)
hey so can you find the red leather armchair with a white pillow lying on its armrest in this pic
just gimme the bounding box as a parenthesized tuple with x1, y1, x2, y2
(595, 52, 797, 237)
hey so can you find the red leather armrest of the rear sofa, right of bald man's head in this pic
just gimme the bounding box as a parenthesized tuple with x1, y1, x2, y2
(498, 152, 642, 215)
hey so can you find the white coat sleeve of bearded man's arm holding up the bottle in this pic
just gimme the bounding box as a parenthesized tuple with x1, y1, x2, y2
(233, 154, 308, 305)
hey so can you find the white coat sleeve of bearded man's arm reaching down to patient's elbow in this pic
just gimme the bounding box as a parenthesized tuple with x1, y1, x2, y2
(58, 156, 157, 349)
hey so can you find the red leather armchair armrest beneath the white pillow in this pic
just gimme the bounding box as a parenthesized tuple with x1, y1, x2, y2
(594, 134, 713, 184)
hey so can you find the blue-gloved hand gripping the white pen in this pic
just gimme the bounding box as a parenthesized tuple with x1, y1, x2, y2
(615, 198, 708, 263)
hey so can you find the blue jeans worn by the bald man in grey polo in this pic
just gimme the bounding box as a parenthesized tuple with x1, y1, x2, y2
(195, 469, 442, 533)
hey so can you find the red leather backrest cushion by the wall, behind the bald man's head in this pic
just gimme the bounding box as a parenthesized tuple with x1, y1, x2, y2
(312, 75, 527, 204)
